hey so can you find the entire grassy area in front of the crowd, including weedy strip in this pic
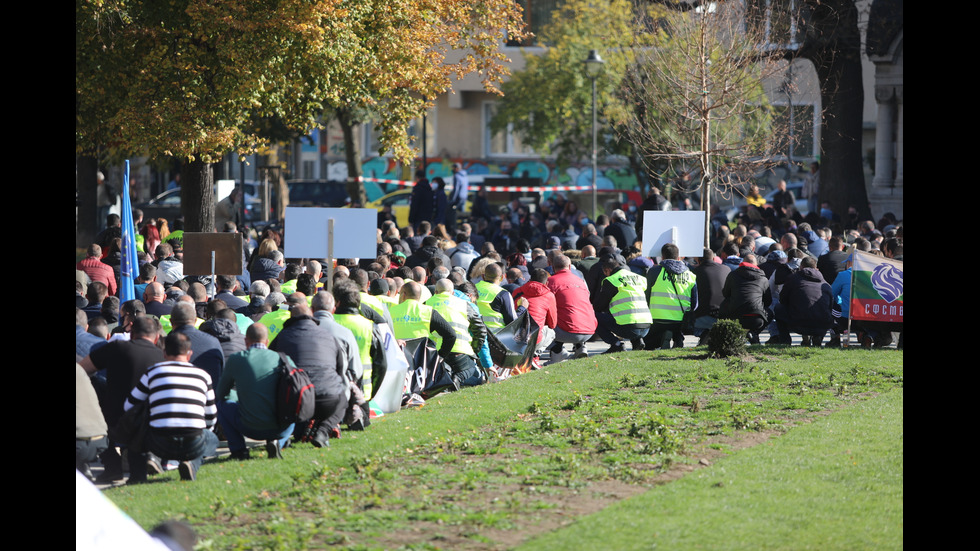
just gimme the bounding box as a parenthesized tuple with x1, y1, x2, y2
(106, 348, 903, 549)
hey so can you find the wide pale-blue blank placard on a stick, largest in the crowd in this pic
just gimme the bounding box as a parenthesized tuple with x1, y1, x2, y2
(284, 207, 378, 259)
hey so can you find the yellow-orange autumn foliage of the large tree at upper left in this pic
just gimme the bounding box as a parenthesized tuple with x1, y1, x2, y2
(75, 0, 523, 163)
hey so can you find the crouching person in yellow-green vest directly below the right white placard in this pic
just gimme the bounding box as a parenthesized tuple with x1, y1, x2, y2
(646, 243, 698, 350)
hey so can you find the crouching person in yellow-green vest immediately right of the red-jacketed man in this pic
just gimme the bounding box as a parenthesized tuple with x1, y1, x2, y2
(594, 255, 653, 354)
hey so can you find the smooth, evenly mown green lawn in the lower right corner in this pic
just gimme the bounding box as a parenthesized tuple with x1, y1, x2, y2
(521, 389, 904, 550)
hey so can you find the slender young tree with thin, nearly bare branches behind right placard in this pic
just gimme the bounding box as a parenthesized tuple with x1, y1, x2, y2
(624, 2, 804, 245)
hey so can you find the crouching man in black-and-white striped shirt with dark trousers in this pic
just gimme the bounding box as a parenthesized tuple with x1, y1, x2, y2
(125, 332, 218, 483)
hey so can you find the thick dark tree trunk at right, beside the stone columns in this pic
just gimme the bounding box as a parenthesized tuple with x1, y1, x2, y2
(800, 0, 871, 224)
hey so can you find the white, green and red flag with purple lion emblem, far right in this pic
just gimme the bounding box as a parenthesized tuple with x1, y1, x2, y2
(850, 251, 905, 322)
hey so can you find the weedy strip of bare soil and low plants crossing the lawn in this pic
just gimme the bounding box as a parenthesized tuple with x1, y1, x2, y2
(209, 366, 896, 550)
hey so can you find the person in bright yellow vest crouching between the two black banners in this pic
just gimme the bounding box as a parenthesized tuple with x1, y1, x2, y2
(425, 279, 487, 386)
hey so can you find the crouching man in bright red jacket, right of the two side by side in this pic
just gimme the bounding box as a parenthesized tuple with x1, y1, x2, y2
(548, 254, 598, 363)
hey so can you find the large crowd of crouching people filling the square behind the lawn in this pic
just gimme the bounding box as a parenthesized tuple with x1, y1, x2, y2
(76, 178, 904, 483)
